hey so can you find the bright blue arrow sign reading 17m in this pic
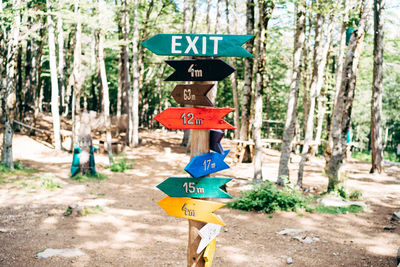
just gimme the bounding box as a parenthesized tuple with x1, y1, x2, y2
(185, 149, 230, 178)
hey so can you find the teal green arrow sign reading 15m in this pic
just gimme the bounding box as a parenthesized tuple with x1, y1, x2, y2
(157, 177, 232, 198)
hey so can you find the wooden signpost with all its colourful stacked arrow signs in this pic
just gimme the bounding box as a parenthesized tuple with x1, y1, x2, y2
(142, 31, 254, 267)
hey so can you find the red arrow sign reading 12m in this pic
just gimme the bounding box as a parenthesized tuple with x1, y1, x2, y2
(154, 108, 235, 129)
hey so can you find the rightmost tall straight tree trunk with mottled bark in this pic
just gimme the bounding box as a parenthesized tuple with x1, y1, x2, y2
(370, 0, 385, 173)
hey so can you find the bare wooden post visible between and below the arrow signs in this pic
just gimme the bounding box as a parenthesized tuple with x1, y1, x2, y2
(187, 82, 216, 267)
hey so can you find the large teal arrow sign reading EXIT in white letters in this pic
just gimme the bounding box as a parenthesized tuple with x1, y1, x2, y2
(142, 33, 254, 57)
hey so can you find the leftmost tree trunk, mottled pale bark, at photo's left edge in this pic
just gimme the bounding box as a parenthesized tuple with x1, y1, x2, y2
(1, 0, 21, 170)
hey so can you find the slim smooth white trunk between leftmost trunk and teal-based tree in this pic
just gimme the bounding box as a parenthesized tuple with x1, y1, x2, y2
(46, 0, 61, 150)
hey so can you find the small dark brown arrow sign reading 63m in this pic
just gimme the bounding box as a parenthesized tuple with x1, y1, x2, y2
(171, 84, 214, 107)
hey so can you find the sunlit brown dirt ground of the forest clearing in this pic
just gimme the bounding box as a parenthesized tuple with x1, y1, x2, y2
(0, 130, 400, 266)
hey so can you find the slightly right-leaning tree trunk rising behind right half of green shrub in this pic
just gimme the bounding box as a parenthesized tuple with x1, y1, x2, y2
(278, 3, 306, 185)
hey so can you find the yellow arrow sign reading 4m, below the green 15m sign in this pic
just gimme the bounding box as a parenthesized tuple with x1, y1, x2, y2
(157, 197, 225, 226)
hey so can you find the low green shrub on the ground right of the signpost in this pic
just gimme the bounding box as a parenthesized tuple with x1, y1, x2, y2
(228, 181, 309, 213)
